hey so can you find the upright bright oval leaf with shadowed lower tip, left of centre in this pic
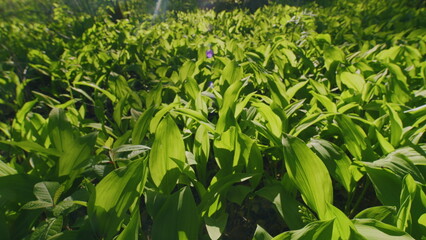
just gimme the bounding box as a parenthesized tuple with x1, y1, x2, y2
(149, 116, 186, 193)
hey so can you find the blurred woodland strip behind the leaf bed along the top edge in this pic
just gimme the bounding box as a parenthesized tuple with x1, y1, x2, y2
(0, 0, 426, 21)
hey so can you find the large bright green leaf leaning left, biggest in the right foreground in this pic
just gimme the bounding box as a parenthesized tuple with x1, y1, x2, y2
(282, 134, 333, 219)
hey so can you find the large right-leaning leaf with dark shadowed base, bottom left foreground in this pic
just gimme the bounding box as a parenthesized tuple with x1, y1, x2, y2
(87, 159, 147, 239)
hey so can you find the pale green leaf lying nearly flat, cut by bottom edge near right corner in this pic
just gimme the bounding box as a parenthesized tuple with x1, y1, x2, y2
(353, 219, 414, 240)
